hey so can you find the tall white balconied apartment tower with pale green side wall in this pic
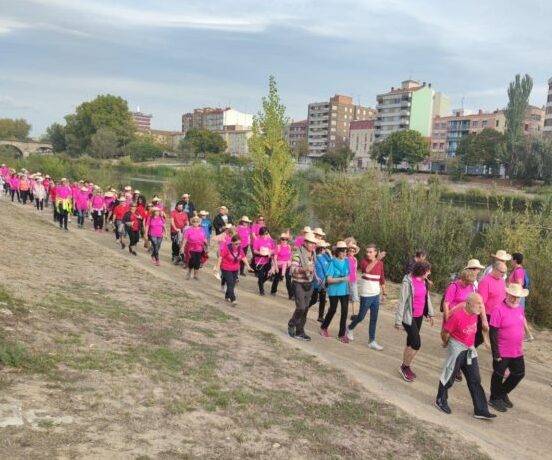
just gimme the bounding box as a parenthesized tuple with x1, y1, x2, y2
(376, 80, 449, 141)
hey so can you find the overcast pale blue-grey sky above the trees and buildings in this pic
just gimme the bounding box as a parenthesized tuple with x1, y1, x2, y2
(0, 0, 552, 135)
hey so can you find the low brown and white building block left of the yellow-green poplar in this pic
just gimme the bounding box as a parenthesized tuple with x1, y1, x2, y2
(182, 107, 253, 133)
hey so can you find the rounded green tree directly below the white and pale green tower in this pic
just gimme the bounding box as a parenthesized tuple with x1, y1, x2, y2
(370, 129, 429, 166)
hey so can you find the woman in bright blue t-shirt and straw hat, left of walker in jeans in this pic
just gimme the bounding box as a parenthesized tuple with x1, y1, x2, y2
(320, 241, 351, 343)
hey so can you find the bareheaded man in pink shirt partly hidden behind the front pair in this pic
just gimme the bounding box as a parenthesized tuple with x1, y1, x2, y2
(475, 261, 507, 347)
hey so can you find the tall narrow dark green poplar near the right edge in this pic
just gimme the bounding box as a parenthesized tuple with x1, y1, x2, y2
(503, 74, 533, 177)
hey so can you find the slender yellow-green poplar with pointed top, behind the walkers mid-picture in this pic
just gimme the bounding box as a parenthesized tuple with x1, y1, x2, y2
(249, 75, 297, 229)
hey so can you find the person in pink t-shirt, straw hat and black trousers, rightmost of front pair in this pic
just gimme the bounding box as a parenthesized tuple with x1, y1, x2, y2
(489, 283, 529, 412)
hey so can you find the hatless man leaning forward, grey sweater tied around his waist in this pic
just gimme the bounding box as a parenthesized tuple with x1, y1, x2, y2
(435, 292, 496, 420)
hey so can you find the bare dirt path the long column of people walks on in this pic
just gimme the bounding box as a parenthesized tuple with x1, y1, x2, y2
(0, 200, 552, 459)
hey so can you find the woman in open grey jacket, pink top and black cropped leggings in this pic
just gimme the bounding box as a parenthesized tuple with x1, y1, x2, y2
(395, 262, 434, 382)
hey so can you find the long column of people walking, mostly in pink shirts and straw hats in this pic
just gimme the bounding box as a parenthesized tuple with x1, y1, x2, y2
(0, 164, 533, 419)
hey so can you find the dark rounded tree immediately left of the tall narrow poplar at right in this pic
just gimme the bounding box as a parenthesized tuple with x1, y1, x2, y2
(456, 128, 505, 174)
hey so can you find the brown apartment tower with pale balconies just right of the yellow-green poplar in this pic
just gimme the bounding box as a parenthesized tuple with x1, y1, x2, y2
(307, 94, 376, 159)
